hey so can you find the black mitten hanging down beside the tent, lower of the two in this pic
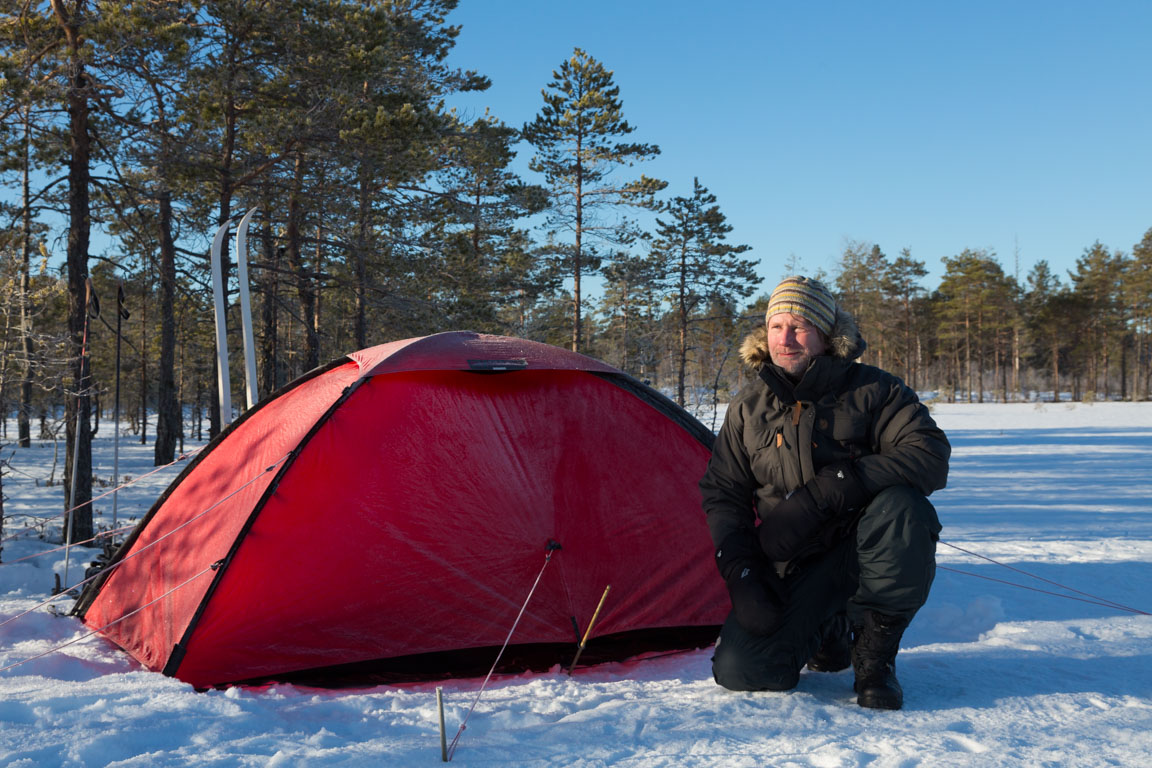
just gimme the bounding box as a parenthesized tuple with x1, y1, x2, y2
(717, 531, 786, 634)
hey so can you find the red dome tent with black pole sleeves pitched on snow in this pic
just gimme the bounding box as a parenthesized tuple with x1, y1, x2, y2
(76, 332, 727, 687)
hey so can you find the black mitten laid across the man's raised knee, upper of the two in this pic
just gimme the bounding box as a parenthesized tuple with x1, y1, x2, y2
(759, 461, 871, 562)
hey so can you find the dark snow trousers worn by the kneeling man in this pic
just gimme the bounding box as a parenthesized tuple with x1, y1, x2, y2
(712, 486, 940, 691)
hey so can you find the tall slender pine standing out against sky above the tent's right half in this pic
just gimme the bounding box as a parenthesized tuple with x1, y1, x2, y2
(523, 48, 666, 351)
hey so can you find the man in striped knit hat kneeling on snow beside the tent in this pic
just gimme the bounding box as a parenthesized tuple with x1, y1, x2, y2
(700, 277, 952, 709)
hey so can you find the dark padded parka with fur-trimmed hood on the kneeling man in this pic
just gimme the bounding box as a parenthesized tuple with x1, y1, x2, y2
(700, 311, 952, 554)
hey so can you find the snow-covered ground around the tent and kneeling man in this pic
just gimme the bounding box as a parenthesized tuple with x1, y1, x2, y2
(0, 403, 1152, 768)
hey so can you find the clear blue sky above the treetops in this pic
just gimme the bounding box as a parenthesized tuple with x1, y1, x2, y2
(449, 0, 1152, 289)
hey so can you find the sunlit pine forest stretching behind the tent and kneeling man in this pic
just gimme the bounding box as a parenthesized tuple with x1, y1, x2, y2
(0, 6, 1152, 537)
